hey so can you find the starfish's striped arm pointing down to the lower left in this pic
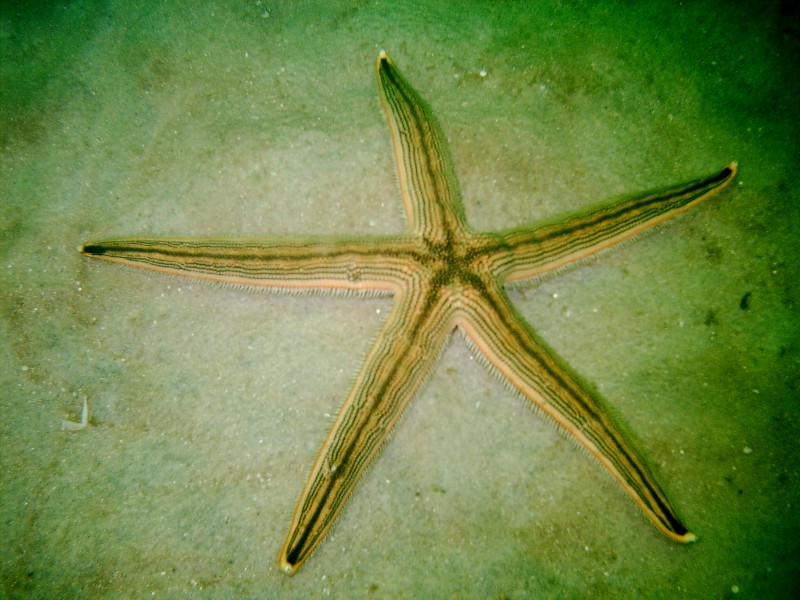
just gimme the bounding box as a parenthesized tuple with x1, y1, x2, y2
(279, 289, 453, 574)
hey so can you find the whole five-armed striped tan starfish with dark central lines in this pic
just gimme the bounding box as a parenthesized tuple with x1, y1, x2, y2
(81, 51, 737, 574)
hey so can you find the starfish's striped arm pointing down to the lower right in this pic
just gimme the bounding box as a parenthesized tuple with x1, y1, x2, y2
(457, 287, 695, 542)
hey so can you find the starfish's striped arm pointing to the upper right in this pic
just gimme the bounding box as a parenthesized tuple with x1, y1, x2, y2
(491, 163, 736, 283)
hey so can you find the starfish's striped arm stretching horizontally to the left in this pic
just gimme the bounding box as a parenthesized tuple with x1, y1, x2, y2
(81, 237, 419, 292)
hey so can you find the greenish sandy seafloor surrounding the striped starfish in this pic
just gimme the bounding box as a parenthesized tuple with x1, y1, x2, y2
(0, 0, 800, 598)
